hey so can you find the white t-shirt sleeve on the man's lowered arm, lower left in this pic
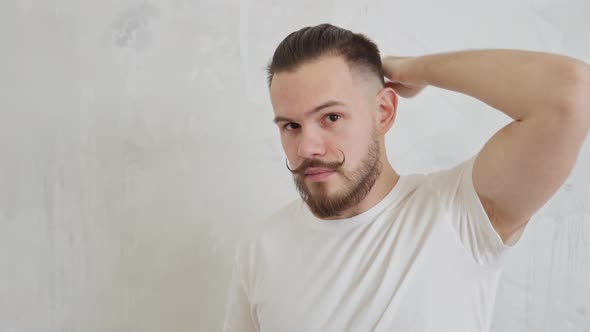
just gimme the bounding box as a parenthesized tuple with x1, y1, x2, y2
(223, 239, 258, 332)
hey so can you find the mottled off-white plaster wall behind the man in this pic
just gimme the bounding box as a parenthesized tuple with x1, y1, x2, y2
(0, 0, 590, 332)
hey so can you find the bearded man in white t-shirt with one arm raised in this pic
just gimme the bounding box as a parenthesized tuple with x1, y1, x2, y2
(224, 24, 590, 332)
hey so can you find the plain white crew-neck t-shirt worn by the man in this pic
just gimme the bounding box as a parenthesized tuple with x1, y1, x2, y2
(223, 156, 525, 332)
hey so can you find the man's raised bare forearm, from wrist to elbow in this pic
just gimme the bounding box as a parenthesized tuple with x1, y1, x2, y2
(406, 50, 590, 120)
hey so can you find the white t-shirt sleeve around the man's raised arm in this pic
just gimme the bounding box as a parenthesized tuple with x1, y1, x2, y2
(429, 155, 526, 265)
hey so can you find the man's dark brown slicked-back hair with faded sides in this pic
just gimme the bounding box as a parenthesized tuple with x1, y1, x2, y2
(267, 24, 385, 87)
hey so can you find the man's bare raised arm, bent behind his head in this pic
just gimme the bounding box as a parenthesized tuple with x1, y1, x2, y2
(383, 50, 590, 244)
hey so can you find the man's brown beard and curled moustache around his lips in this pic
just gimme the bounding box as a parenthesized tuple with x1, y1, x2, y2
(292, 135, 383, 218)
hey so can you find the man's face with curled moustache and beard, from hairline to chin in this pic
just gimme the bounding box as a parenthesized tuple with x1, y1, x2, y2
(270, 57, 382, 218)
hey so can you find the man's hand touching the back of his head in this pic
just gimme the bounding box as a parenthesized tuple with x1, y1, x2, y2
(381, 56, 427, 98)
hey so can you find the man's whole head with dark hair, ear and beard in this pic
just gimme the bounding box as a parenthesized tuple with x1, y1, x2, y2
(268, 24, 397, 218)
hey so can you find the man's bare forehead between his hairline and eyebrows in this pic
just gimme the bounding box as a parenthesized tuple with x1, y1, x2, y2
(270, 56, 360, 113)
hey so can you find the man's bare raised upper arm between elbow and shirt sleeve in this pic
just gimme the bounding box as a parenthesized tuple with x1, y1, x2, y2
(473, 112, 587, 238)
